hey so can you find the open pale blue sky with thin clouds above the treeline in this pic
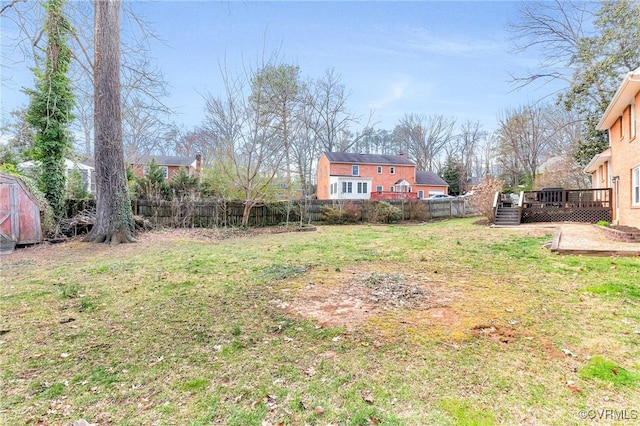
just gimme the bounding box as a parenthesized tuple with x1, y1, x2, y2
(0, 1, 557, 138)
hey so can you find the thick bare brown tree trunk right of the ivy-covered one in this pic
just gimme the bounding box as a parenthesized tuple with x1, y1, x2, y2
(87, 0, 135, 244)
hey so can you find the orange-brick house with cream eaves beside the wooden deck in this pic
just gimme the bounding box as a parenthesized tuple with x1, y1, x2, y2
(584, 68, 640, 228)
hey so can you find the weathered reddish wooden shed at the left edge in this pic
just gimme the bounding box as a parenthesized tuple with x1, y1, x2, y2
(0, 173, 42, 253)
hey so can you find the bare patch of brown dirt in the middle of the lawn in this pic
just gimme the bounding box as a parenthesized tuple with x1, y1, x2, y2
(277, 271, 458, 331)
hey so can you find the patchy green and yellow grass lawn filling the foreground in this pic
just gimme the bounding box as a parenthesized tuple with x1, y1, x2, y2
(0, 219, 640, 426)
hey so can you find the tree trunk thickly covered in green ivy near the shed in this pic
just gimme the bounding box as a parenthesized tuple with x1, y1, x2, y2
(26, 0, 74, 222)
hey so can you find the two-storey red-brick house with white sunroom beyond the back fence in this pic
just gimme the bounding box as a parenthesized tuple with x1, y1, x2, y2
(318, 152, 448, 200)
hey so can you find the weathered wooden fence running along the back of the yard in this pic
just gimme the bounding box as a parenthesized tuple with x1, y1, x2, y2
(67, 198, 476, 228)
